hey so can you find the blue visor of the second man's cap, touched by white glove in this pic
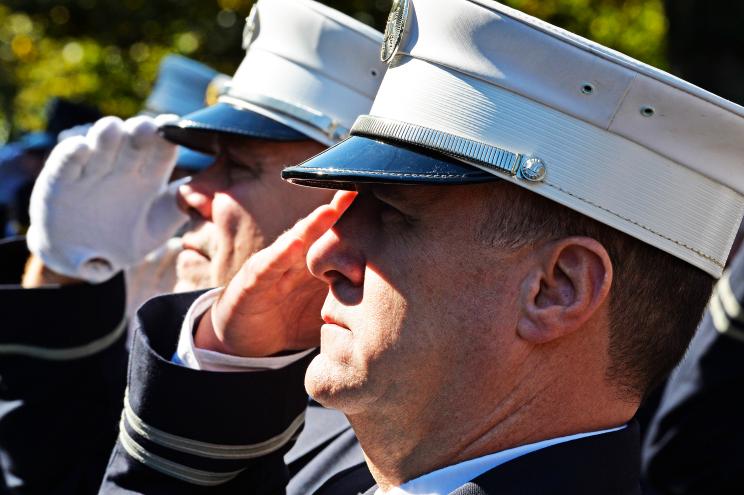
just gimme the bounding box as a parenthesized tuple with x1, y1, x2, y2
(160, 103, 312, 155)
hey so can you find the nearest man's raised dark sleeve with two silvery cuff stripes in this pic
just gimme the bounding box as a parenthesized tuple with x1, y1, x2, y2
(100, 294, 312, 494)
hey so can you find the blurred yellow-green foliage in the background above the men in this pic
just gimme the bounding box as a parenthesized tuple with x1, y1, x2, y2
(0, 0, 667, 143)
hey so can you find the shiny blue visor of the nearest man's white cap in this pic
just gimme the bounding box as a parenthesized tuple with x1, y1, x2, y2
(282, 136, 500, 189)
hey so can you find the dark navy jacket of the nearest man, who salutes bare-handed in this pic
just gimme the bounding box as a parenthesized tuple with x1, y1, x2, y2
(101, 293, 640, 495)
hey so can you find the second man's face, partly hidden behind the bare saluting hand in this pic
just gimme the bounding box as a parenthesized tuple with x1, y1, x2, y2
(176, 136, 332, 291)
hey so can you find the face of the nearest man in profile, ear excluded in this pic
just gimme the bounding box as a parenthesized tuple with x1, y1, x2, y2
(305, 184, 529, 416)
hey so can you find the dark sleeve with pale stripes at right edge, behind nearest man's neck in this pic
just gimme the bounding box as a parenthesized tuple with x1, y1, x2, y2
(643, 251, 744, 494)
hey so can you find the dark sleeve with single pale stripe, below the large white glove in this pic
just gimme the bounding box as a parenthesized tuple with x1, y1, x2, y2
(0, 241, 126, 494)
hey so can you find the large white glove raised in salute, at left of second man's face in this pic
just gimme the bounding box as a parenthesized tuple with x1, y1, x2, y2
(27, 116, 188, 283)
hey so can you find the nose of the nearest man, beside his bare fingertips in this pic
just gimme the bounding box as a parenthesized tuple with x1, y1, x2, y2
(307, 203, 366, 289)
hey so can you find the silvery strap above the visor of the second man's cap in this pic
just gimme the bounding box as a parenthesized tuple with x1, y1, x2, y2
(220, 91, 349, 141)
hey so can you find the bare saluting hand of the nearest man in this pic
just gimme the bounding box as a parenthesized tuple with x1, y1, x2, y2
(194, 191, 356, 357)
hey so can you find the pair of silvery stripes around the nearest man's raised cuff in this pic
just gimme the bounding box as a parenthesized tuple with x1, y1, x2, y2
(122, 395, 305, 460)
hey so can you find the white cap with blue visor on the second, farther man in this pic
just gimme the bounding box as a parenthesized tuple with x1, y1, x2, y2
(162, 0, 387, 152)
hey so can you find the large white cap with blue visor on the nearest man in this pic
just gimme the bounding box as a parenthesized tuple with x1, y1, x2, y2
(283, 0, 744, 277)
